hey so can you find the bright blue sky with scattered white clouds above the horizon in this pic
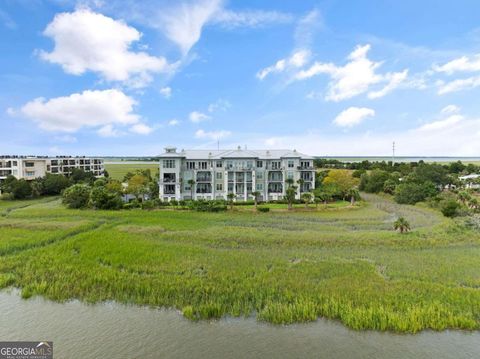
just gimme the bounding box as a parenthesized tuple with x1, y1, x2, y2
(0, 0, 480, 156)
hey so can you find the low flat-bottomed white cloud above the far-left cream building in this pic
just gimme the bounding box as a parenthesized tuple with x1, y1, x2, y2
(20, 89, 140, 133)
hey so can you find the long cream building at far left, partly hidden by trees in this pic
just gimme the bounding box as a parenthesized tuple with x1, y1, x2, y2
(0, 156, 105, 181)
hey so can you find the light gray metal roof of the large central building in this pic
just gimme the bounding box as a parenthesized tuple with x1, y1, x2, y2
(159, 149, 313, 160)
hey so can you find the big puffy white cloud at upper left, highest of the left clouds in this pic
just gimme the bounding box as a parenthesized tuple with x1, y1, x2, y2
(40, 9, 171, 87)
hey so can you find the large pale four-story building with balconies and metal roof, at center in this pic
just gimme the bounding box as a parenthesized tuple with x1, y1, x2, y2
(159, 147, 315, 201)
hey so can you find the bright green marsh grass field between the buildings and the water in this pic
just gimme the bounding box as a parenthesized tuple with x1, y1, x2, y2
(0, 195, 480, 332)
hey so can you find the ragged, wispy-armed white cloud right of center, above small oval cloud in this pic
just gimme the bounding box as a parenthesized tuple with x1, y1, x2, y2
(295, 45, 408, 101)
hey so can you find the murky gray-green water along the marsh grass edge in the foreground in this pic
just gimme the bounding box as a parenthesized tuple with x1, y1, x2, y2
(0, 291, 480, 359)
